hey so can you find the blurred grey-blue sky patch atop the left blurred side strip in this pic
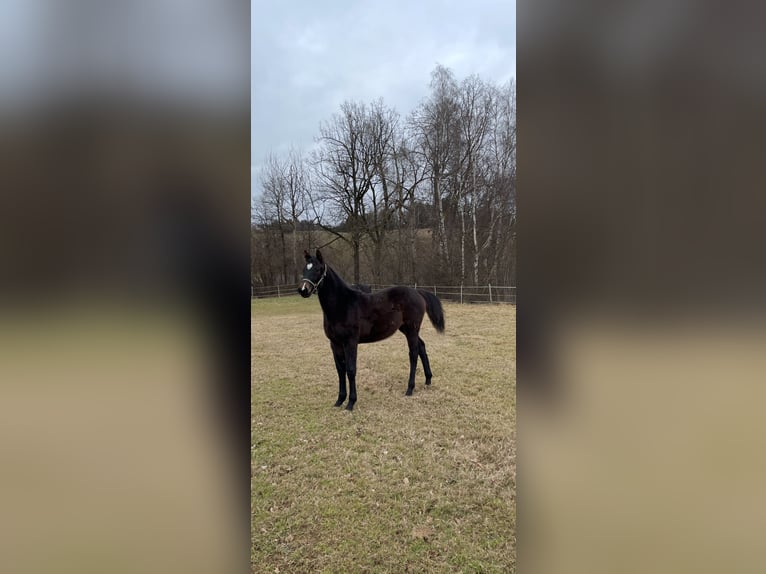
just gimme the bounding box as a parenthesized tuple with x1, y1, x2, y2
(0, 0, 250, 112)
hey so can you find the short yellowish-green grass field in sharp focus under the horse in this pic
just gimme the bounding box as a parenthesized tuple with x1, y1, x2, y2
(251, 297, 516, 574)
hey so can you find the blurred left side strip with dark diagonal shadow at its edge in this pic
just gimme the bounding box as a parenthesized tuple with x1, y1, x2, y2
(0, 0, 251, 572)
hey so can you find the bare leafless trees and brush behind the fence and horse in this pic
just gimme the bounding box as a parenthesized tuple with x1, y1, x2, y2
(251, 66, 516, 286)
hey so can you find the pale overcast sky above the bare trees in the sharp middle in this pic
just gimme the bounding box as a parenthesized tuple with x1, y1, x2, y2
(251, 0, 516, 198)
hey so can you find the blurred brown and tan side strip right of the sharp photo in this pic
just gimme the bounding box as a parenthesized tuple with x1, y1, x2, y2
(517, 0, 766, 573)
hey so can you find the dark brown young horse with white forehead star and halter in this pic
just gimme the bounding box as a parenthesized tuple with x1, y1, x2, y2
(298, 249, 444, 411)
